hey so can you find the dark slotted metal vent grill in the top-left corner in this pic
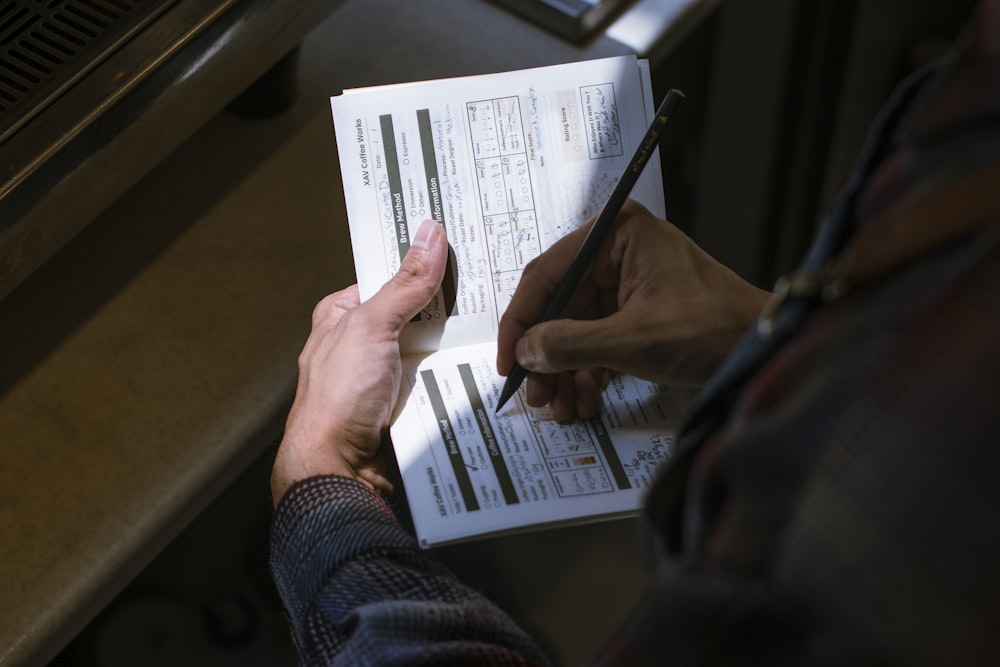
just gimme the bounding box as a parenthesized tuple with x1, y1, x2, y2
(0, 0, 175, 143)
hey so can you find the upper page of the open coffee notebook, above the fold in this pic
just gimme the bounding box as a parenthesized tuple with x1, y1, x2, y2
(331, 56, 664, 352)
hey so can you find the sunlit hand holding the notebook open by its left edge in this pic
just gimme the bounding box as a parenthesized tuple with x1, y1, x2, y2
(271, 221, 448, 505)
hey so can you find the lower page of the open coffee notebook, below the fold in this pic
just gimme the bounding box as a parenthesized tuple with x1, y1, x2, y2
(392, 343, 684, 546)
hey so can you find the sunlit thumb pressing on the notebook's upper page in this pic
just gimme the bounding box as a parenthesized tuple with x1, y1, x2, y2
(369, 220, 448, 328)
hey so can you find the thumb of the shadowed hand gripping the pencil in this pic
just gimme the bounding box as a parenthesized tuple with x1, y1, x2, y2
(514, 316, 622, 374)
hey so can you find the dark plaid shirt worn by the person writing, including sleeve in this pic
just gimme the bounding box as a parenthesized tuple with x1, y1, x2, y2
(272, 0, 1000, 665)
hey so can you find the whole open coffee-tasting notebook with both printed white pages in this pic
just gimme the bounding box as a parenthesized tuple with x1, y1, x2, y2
(331, 56, 680, 546)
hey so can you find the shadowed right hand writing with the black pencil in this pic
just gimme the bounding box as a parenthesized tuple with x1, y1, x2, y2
(497, 200, 768, 422)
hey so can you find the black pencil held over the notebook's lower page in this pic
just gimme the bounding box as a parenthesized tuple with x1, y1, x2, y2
(496, 88, 684, 412)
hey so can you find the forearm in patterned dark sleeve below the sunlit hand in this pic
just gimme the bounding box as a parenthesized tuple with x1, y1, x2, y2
(271, 476, 545, 664)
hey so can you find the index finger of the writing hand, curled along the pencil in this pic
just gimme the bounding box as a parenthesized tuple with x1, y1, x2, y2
(497, 225, 589, 375)
